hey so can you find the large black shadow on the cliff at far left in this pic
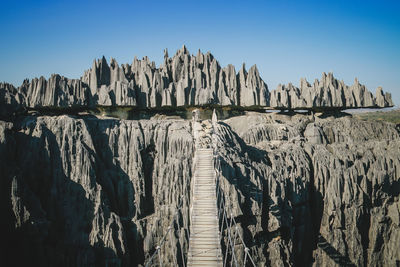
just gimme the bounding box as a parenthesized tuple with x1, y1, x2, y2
(2, 126, 101, 266)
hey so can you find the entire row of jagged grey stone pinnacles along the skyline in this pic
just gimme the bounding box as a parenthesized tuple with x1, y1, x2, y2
(0, 46, 393, 116)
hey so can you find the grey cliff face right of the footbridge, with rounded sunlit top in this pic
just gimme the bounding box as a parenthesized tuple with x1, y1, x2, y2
(218, 114, 400, 266)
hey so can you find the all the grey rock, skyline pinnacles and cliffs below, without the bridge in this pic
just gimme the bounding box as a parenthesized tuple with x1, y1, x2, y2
(0, 47, 400, 266)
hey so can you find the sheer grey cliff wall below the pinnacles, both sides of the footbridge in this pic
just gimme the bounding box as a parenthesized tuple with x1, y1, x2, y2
(0, 110, 400, 266)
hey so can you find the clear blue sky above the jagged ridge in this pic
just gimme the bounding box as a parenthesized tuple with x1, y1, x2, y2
(0, 0, 400, 105)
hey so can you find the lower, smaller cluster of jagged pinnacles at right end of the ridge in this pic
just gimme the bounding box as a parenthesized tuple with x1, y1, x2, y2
(271, 73, 393, 109)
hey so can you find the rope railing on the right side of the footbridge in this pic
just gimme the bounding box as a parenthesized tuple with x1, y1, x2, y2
(213, 123, 256, 267)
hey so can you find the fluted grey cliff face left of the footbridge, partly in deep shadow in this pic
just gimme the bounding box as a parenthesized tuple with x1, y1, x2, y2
(0, 116, 193, 266)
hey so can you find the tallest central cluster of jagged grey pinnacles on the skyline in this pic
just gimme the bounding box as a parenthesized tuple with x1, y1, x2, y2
(82, 46, 268, 108)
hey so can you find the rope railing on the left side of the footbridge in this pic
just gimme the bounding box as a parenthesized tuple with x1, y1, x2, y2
(144, 191, 190, 267)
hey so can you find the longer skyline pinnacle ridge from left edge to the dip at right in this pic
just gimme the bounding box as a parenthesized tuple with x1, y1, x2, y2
(0, 46, 269, 112)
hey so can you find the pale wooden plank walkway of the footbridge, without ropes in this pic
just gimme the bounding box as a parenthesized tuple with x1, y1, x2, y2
(187, 148, 222, 266)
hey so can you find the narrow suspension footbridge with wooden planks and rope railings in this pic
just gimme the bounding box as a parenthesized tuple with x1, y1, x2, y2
(144, 118, 256, 267)
